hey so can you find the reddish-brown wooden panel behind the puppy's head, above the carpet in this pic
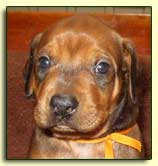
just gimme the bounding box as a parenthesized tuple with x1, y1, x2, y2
(7, 12, 151, 55)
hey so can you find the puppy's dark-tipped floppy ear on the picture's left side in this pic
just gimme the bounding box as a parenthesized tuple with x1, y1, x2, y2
(23, 33, 42, 97)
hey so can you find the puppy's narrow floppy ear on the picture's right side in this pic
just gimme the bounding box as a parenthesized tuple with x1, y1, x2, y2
(123, 39, 137, 104)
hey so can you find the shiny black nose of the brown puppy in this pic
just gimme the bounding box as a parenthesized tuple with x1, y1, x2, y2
(50, 94, 78, 118)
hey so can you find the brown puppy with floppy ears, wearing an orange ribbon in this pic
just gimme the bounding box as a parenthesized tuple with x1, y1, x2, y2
(25, 15, 142, 159)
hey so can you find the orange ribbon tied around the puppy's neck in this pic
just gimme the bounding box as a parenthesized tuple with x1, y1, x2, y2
(76, 129, 141, 159)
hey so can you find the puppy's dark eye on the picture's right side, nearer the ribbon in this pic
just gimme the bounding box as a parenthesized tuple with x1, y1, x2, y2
(95, 61, 110, 74)
